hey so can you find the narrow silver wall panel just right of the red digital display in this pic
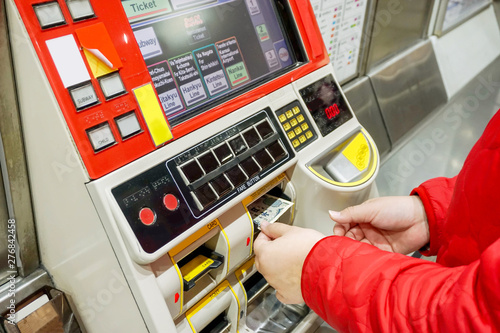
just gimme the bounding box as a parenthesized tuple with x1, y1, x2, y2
(343, 76, 391, 156)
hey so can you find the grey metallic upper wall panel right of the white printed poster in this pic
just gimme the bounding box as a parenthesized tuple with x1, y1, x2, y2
(366, 0, 434, 71)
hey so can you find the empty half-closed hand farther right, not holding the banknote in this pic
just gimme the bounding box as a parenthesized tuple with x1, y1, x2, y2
(330, 196, 429, 254)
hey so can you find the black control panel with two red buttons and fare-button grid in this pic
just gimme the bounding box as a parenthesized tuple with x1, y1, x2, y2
(112, 109, 295, 253)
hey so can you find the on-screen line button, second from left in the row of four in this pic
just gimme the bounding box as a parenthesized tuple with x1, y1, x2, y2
(168, 53, 207, 106)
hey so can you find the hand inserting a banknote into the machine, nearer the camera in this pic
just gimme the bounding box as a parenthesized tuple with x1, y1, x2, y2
(254, 222, 325, 304)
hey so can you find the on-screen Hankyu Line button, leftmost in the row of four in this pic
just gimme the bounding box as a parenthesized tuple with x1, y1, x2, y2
(148, 61, 184, 116)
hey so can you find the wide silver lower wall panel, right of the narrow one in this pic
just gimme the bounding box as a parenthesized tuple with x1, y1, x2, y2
(368, 41, 448, 146)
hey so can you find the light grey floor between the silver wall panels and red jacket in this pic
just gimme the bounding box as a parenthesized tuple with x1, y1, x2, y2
(376, 55, 500, 196)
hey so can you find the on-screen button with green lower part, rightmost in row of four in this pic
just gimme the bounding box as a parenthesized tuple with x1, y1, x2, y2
(216, 37, 250, 87)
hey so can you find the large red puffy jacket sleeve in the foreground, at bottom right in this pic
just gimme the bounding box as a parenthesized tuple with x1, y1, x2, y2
(302, 236, 500, 332)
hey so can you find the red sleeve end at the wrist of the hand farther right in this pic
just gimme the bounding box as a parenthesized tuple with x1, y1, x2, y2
(411, 177, 457, 256)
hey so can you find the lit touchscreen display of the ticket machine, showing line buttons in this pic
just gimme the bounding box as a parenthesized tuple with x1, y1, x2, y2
(122, 0, 297, 126)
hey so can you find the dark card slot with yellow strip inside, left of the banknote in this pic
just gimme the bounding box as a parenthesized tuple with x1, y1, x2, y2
(178, 245, 224, 291)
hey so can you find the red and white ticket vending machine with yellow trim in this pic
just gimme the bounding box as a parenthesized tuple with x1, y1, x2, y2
(6, 0, 379, 333)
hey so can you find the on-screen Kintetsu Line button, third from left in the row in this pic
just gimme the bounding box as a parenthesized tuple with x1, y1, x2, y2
(194, 45, 229, 96)
